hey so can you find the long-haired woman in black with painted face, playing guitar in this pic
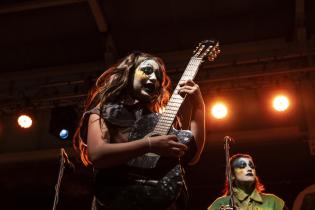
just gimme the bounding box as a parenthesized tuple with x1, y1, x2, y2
(73, 52, 205, 210)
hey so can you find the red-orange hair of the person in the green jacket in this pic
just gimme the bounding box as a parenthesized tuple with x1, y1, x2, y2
(223, 153, 265, 195)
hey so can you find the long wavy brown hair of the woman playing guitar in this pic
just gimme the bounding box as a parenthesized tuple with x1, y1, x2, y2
(73, 52, 171, 166)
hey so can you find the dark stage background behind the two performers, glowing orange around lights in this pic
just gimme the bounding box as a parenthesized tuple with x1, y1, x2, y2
(0, 0, 315, 210)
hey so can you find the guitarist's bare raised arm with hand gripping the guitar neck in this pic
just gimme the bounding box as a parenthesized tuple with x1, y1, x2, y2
(179, 80, 205, 165)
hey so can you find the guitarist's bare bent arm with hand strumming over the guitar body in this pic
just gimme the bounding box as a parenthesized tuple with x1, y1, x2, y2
(87, 114, 187, 168)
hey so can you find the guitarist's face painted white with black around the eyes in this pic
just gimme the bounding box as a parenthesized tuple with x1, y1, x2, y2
(133, 59, 162, 101)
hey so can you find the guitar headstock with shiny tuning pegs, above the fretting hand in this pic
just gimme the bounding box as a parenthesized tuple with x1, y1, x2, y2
(193, 40, 220, 61)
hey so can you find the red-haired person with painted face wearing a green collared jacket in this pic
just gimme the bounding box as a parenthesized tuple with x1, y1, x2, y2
(208, 154, 287, 210)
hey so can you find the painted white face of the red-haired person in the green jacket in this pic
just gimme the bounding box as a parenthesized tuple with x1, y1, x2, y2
(232, 157, 256, 182)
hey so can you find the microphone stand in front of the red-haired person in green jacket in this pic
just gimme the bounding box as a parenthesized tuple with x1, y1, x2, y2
(220, 136, 235, 210)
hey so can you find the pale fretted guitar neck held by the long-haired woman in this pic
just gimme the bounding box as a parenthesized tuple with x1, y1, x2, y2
(153, 57, 202, 135)
